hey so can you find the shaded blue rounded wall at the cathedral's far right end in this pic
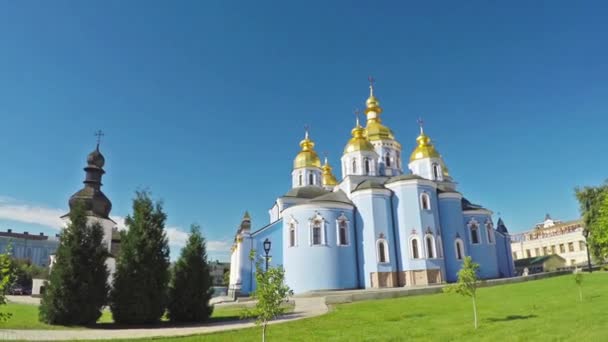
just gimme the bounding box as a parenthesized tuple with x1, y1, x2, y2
(464, 212, 499, 279)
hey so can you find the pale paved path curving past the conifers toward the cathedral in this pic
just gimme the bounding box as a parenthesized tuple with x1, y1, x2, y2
(0, 297, 327, 341)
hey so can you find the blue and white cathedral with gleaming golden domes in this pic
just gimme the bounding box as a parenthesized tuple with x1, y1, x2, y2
(229, 81, 515, 295)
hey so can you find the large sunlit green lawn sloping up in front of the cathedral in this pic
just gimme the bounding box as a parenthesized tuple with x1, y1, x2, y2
(92, 272, 608, 342)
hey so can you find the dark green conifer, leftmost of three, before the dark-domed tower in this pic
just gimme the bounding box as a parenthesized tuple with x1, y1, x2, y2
(39, 203, 109, 325)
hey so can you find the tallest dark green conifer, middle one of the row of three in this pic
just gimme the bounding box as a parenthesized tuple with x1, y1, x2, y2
(110, 191, 169, 324)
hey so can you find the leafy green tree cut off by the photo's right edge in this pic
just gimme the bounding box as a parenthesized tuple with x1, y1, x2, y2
(575, 181, 608, 262)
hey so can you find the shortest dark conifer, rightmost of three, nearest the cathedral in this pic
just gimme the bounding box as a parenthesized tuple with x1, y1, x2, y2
(168, 225, 213, 322)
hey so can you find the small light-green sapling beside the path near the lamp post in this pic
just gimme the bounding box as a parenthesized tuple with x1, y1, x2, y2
(243, 250, 291, 341)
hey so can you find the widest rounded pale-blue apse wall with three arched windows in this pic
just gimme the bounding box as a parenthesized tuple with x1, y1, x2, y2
(282, 202, 358, 293)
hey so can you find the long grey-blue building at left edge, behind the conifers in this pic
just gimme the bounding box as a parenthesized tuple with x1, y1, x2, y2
(0, 229, 59, 267)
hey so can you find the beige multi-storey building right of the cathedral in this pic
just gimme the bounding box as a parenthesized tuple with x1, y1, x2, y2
(511, 214, 587, 266)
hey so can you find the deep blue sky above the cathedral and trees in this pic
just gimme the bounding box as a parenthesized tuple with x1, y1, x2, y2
(0, 1, 608, 259)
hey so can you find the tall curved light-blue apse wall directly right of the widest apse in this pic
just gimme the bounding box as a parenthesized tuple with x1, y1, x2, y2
(352, 190, 397, 288)
